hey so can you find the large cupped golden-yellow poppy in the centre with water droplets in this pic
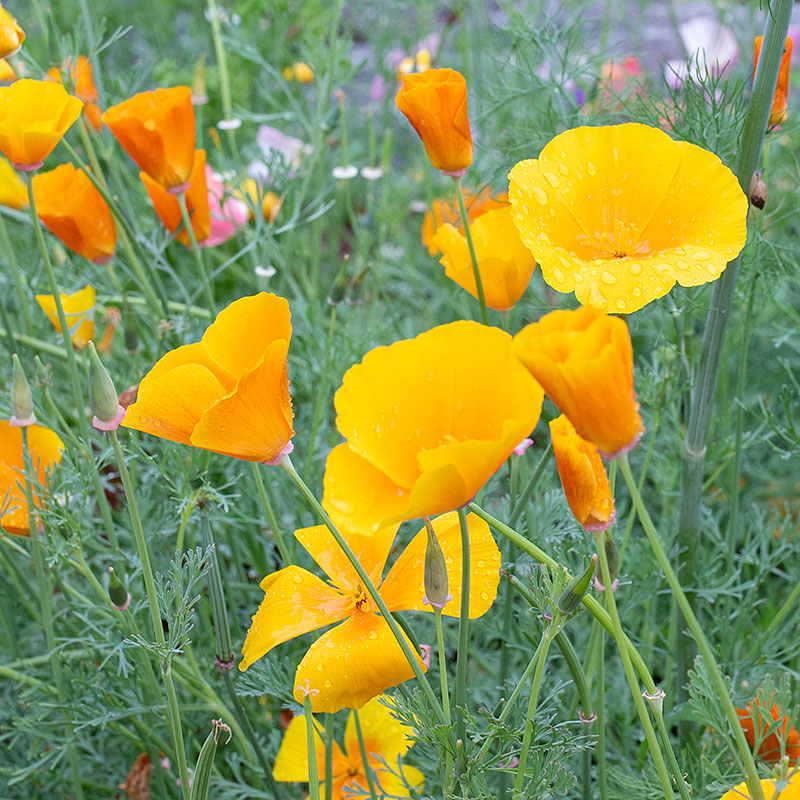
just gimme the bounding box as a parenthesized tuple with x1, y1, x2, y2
(325, 321, 543, 531)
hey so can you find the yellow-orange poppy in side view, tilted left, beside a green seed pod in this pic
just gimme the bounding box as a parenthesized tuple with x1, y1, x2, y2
(122, 292, 294, 463)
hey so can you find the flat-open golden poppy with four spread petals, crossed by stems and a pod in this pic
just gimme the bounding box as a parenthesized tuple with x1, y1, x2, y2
(239, 512, 500, 713)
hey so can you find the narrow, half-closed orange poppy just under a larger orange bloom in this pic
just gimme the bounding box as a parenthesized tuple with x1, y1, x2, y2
(550, 414, 616, 531)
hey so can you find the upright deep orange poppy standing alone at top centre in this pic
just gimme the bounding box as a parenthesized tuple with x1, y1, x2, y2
(395, 69, 472, 175)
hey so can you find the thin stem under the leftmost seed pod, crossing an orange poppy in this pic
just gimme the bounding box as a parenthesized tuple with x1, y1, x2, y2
(22, 426, 83, 800)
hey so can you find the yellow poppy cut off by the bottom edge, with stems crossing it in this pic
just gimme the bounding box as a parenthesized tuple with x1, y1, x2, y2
(272, 697, 424, 800)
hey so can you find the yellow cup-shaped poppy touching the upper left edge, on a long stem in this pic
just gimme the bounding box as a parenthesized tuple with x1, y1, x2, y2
(0, 78, 83, 172)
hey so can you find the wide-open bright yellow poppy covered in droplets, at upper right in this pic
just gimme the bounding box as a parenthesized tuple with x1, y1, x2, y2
(508, 122, 747, 313)
